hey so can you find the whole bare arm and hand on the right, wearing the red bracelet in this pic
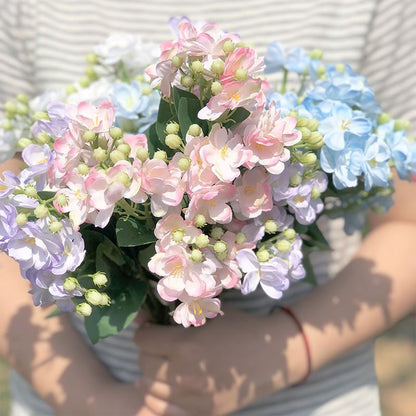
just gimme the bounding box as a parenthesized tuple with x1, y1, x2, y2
(136, 176, 416, 415)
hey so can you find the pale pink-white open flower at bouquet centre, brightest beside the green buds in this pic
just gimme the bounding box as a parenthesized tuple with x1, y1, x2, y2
(199, 124, 251, 183)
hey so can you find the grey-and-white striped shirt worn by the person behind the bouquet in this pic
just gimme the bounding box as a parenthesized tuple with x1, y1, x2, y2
(0, 0, 416, 416)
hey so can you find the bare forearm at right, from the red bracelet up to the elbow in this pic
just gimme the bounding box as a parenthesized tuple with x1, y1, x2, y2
(292, 222, 416, 370)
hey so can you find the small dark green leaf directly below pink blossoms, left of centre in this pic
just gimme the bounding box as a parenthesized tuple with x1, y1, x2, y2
(116, 217, 156, 247)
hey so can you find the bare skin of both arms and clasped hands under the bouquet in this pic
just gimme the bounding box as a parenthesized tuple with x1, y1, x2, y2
(0, 157, 416, 416)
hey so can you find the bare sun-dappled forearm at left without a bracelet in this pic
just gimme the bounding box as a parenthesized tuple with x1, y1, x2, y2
(0, 254, 136, 415)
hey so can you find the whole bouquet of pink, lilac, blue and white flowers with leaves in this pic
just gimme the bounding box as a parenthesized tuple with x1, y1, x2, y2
(0, 18, 416, 343)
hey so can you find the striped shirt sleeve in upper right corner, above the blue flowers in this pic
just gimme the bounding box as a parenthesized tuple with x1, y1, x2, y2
(362, 0, 416, 136)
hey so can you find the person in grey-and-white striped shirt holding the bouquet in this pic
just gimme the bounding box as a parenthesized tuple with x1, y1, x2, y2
(0, 0, 416, 416)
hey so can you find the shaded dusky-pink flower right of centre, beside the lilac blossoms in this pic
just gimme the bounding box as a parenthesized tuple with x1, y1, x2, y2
(232, 167, 273, 219)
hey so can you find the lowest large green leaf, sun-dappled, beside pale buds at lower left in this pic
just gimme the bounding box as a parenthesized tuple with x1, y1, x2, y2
(85, 280, 147, 344)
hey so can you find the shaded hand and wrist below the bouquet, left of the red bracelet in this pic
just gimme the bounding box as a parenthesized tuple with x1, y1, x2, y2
(135, 310, 306, 416)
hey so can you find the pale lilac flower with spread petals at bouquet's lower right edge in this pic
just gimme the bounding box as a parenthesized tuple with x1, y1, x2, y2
(236, 249, 289, 299)
